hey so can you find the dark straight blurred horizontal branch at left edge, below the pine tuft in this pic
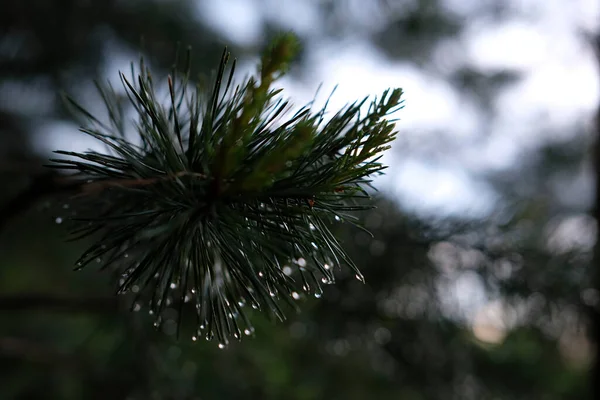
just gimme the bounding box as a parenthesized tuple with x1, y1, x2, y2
(0, 294, 118, 314)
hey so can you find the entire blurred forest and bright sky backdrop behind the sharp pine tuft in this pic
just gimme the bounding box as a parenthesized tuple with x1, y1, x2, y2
(0, 0, 600, 400)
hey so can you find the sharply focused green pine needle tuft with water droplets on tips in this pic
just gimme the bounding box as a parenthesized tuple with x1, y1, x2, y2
(51, 35, 402, 347)
